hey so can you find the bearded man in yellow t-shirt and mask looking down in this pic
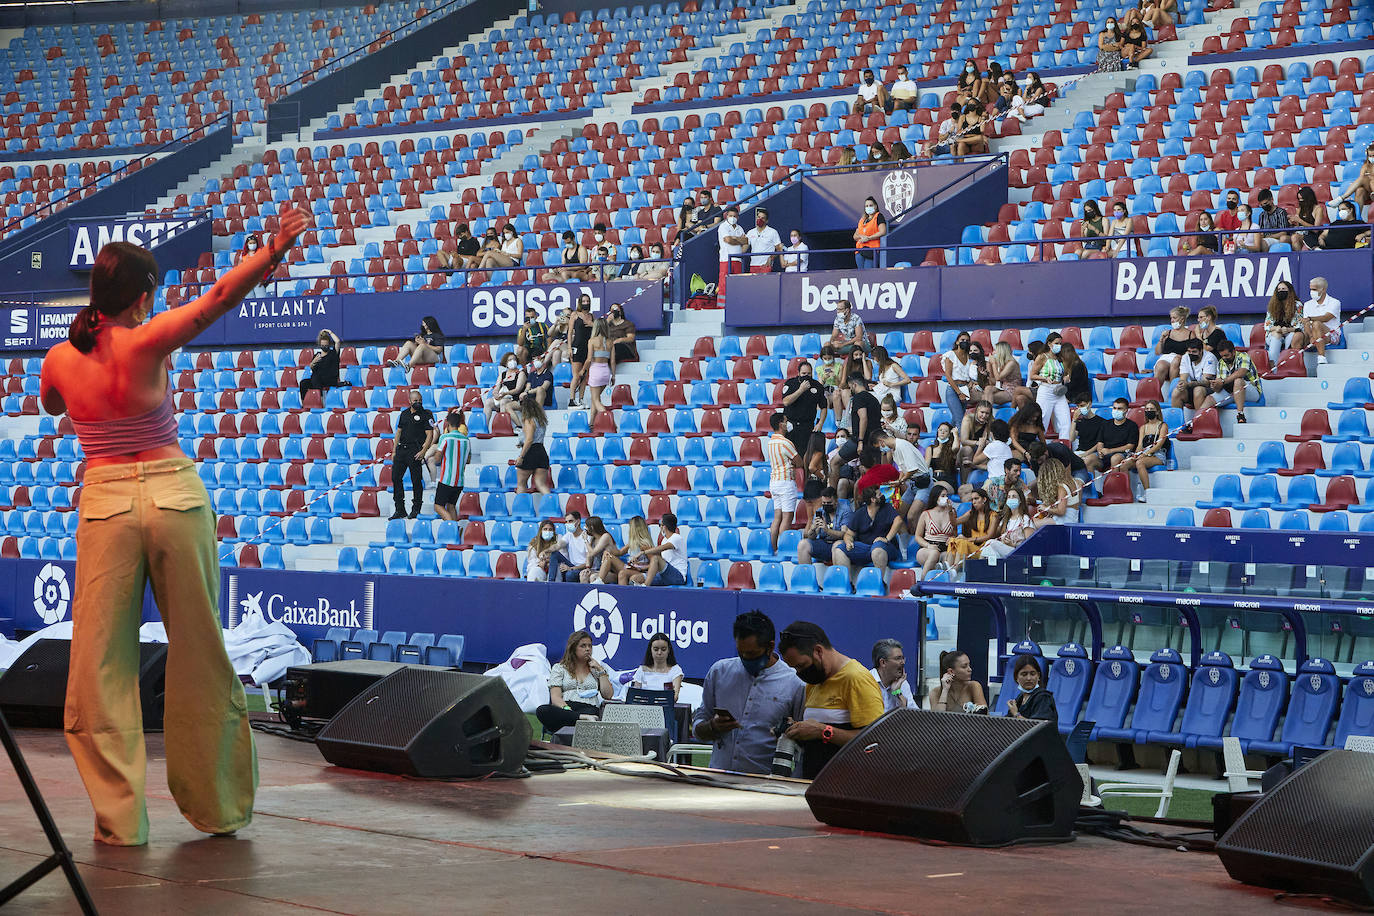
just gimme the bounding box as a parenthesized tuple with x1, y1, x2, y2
(778, 621, 883, 779)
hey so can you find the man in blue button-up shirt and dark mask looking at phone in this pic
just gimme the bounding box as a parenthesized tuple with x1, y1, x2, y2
(692, 611, 807, 773)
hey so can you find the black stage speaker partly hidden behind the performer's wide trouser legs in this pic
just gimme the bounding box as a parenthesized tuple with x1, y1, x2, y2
(0, 640, 168, 732)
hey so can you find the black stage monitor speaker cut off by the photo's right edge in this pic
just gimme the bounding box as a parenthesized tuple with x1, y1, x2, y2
(1216, 751, 1374, 906)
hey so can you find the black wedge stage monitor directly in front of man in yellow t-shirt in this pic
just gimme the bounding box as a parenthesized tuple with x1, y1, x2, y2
(807, 709, 1083, 846)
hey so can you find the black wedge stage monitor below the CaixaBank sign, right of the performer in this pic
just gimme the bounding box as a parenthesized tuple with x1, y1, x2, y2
(315, 666, 532, 776)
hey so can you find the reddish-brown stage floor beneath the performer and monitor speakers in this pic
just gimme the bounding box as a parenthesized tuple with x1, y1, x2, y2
(0, 731, 1274, 916)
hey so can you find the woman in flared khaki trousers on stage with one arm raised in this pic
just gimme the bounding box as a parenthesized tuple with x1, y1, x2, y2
(41, 210, 308, 846)
